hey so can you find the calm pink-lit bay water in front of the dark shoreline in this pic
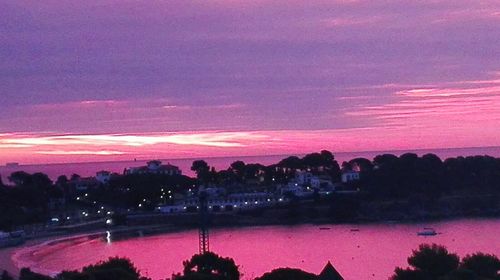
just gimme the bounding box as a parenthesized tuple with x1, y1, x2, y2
(11, 219, 500, 280)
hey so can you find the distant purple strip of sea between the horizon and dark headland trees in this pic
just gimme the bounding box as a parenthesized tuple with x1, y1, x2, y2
(0, 146, 500, 180)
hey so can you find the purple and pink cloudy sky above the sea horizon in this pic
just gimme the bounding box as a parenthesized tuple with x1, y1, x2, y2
(0, 0, 500, 164)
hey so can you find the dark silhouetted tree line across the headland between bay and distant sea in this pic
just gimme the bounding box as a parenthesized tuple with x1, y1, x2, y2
(0, 150, 500, 230)
